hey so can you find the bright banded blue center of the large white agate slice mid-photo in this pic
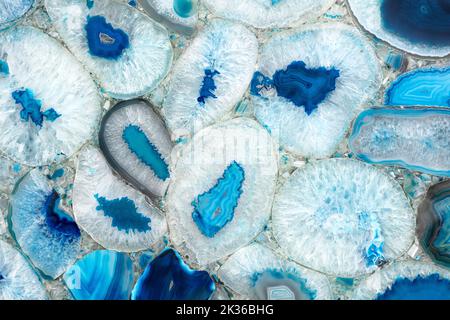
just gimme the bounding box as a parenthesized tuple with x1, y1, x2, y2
(192, 161, 245, 238)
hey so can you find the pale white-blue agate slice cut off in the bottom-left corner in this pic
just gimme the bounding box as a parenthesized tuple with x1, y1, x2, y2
(0, 240, 47, 300)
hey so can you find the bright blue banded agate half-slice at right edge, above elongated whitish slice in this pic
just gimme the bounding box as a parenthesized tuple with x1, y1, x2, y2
(384, 68, 450, 107)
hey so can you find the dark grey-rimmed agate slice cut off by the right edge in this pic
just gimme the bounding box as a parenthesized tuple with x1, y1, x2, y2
(417, 180, 450, 267)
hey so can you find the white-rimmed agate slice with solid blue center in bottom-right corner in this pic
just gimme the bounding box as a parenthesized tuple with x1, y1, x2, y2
(353, 261, 450, 300)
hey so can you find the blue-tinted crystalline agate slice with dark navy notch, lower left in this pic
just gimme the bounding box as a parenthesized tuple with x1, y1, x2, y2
(9, 169, 81, 279)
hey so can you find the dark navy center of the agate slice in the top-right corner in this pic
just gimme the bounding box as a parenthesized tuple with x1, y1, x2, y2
(381, 0, 450, 46)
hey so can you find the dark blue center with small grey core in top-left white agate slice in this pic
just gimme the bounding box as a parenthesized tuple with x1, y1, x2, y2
(85, 16, 130, 59)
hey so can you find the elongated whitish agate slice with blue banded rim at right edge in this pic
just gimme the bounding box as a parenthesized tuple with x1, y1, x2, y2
(349, 107, 450, 176)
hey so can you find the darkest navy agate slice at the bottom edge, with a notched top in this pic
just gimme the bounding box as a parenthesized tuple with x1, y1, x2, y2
(131, 249, 215, 300)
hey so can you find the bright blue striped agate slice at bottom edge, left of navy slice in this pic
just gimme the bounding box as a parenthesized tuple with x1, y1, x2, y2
(64, 250, 133, 300)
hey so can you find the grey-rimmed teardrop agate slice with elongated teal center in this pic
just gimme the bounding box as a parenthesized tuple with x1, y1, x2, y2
(99, 99, 172, 196)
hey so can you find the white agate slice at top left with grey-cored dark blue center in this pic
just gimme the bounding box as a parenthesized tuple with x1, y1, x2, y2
(45, 0, 172, 99)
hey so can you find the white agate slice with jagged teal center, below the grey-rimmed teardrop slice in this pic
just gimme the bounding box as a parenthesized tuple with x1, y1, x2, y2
(72, 146, 167, 252)
